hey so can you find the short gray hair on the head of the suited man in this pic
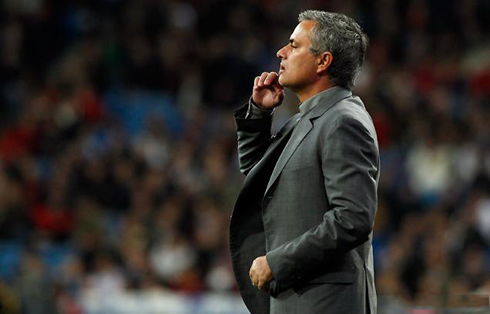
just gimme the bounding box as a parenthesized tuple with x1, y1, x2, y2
(298, 10, 369, 89)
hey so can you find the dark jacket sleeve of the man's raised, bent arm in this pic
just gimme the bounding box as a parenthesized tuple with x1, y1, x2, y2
(235, 101, 272, 175)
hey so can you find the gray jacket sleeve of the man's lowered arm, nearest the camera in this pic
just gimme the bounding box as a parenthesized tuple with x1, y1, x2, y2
(266, 117, 379, 296)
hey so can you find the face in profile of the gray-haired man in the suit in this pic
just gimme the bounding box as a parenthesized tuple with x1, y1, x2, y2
(277, 21, 319, 91)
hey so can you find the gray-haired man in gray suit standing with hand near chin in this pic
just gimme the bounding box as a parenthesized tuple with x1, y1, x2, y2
(230, 11, 379, 314)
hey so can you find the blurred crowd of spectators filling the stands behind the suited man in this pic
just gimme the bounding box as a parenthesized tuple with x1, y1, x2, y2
(0, 0, 490, 313)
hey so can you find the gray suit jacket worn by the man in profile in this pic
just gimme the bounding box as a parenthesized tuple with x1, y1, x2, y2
(230, 87, 379, 314)
